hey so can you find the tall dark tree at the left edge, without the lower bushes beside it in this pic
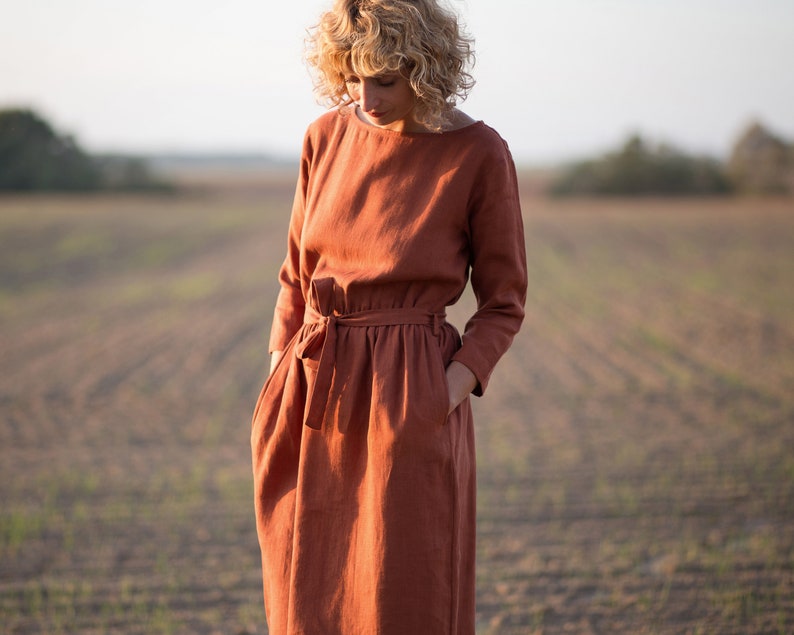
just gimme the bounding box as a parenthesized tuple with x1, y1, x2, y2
(0, 109, 102, 190)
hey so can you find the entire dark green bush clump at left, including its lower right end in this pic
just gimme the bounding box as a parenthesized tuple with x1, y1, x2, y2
(0, 109, 171, 192)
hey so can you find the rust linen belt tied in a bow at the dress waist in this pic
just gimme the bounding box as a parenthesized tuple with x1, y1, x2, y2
(295, 306, 446, 430)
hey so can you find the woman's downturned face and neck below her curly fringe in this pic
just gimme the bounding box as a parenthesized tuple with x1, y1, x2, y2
(345, 73, 426, 132)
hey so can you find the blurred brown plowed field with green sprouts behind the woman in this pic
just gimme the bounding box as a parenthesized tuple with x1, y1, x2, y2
(0, 181, 794, 635)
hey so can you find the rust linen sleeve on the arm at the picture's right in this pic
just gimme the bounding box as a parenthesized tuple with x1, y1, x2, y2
(453, 139, 527, 395)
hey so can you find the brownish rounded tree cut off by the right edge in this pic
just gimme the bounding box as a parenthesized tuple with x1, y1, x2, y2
(728, 122, 794, 194)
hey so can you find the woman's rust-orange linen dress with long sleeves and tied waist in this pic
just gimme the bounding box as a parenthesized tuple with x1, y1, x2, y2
(251, 109, 527, 635)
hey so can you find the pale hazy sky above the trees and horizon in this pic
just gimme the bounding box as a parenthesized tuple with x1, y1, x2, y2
(0, 0, 794, 164)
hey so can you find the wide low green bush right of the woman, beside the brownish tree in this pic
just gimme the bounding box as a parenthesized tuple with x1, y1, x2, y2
(550, 135, 731, 196)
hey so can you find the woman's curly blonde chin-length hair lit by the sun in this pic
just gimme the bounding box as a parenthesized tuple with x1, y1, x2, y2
(306, 0, 474, 132)
